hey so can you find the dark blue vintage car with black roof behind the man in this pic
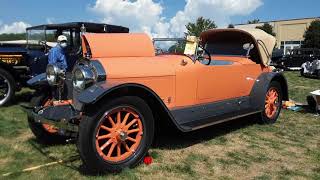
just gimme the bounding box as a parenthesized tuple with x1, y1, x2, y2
(0, 22, 129, 106)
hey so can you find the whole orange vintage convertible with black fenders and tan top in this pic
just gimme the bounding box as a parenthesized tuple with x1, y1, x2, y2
(28, 29, 288, 172)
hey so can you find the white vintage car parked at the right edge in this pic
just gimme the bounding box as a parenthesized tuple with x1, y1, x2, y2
(300, 59, 320, 78)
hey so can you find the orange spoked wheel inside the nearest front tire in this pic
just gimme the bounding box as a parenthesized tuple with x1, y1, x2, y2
(95, 107, 143, 163)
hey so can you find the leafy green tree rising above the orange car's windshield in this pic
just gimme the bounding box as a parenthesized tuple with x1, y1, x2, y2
(186, 17, 217, 37)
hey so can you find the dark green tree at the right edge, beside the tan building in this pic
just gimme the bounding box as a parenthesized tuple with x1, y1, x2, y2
(303, 20, 320, 49)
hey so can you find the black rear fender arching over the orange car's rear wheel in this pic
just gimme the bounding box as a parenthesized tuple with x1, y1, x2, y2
(250, 72, 289, 111)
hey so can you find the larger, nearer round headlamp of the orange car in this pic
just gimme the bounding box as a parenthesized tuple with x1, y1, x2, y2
(73, 65, 96, 91)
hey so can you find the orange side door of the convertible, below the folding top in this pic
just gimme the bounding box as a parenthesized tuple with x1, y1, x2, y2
(197, 57, 247, 103)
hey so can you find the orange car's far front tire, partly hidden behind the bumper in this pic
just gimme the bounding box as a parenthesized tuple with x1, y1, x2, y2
(28, 93, 68, 145)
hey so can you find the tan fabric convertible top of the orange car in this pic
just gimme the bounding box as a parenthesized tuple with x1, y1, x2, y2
(201, 28, 276, 66)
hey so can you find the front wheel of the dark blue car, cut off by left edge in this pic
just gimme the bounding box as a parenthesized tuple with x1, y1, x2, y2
(0, 68, 16, 106)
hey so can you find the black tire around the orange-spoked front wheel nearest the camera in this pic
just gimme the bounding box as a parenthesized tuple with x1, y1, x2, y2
(77, 96, 154, 174)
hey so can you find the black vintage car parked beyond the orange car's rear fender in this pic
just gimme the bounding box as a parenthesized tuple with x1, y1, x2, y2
(277, 48, 320, 70)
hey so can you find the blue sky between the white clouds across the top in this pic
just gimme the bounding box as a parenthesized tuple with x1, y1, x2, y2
(0, 0, 320, 35)
